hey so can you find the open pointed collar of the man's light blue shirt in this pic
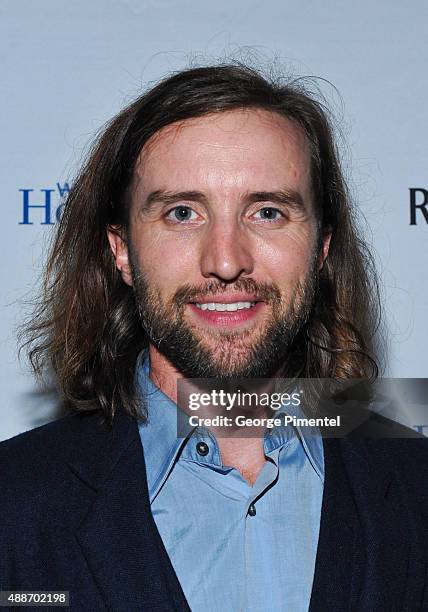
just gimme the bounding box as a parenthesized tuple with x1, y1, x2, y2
(137, 351, 324, 502)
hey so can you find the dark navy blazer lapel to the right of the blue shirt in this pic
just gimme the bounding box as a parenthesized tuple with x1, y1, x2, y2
(310, 439, 416, 612)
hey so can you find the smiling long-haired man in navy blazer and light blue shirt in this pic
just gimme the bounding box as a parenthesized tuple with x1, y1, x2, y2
(0, 66, 428, 612)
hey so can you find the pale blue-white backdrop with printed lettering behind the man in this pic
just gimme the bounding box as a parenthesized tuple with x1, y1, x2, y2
(0, 0, 428, 439)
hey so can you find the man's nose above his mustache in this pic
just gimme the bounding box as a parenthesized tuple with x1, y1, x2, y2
(201, 223, 254, 282)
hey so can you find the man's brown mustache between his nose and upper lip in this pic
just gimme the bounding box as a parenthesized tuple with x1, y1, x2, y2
(171, 278, 281, 307)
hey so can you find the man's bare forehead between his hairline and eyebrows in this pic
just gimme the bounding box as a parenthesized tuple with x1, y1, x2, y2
(135, 109, 310, 196)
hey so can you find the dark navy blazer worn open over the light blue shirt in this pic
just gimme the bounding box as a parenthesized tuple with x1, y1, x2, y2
(0, 412, 428, 612)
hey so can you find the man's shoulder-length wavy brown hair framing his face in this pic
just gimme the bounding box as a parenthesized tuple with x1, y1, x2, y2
(20, 64, 379, 421)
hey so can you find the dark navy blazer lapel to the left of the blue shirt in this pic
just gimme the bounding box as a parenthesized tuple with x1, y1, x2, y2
(70, 415, 189, 612)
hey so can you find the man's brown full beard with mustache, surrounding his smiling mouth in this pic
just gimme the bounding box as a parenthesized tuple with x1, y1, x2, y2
(130, 253, 318, 379)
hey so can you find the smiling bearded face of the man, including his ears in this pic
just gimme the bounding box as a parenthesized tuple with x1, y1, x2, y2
(110, 109, 328, 377)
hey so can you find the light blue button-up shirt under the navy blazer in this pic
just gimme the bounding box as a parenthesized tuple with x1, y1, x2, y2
(138, 357, 324, 612)
